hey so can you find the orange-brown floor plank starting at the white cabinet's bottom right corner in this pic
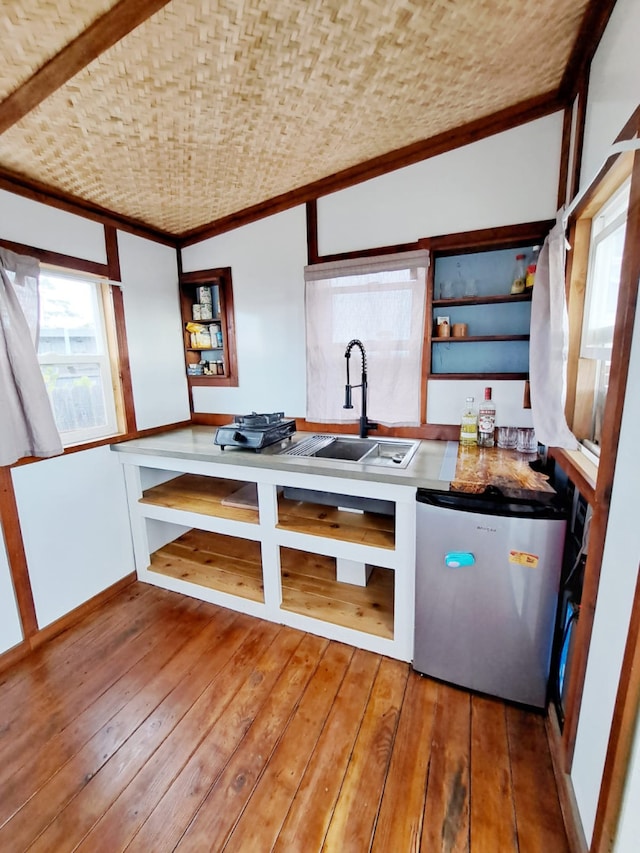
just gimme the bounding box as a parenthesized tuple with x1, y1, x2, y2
(322, 658, 408, 853)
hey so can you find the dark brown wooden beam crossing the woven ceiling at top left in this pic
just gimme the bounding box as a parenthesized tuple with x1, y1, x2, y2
(0, 0, 169, 133)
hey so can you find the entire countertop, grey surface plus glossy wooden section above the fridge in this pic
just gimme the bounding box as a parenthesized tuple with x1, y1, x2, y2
(111, 426, 554, 498)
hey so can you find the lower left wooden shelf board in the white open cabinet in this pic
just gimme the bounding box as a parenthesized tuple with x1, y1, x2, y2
(149, 529, 264, 603)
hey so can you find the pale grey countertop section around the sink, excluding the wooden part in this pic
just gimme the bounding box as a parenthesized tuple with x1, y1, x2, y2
(111, 426, 449, 490)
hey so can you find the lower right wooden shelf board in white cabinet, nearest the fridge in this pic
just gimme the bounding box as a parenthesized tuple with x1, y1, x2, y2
(280, 547, 395, 640)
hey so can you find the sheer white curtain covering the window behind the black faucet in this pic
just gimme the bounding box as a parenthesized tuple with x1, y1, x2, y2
(305, 251, 429, 426)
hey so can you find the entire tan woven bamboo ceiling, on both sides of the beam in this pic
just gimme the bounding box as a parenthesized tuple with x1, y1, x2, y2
(0, 0, 588, 235)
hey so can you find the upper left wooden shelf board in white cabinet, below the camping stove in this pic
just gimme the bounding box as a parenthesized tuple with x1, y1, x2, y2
(140, 474, 259, 524)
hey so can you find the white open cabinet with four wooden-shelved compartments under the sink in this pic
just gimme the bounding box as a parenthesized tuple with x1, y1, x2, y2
(121, 454, 416, 661)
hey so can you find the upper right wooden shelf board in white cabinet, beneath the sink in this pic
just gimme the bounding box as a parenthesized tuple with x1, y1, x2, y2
(277, 496, 395, 550)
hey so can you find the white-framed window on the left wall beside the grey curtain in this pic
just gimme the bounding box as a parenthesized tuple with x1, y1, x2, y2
(38, 268, 123, 446)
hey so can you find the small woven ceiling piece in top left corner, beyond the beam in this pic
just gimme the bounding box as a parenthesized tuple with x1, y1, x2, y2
(0, 0, 118, 99)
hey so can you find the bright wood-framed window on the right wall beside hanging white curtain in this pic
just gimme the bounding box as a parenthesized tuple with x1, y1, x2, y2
(573, 180, 630, 458)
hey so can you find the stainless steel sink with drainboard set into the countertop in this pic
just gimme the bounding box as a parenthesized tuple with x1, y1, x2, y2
(279, 435, 420, 468)
